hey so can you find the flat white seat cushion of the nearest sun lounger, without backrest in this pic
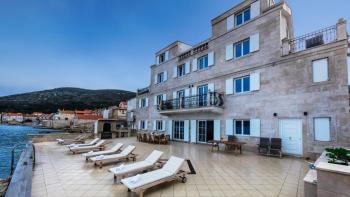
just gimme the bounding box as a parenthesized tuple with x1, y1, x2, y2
(121, 169, 172, 190)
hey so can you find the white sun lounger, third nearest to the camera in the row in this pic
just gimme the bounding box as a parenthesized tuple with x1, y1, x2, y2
(89, 145, 136, 168)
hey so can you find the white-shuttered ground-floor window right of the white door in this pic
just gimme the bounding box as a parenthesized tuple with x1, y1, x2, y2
(314, 118, 331, 142)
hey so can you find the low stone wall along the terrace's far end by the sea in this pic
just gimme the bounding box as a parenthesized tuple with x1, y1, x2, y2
(28, 133, 85, 143)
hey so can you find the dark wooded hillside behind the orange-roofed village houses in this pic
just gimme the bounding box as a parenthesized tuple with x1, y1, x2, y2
(0, 88, 135, 113)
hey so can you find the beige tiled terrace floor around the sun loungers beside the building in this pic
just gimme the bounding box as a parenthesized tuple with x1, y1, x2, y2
(32, 138, 307, 197)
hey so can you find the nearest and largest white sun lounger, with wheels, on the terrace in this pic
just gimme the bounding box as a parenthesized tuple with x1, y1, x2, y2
(121, 156, 186, 197)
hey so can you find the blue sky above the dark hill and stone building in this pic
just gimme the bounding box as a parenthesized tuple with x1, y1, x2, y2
(0, 0, 350, 96)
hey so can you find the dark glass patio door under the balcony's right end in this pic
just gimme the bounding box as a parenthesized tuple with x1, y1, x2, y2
(197, 120, 214, 143)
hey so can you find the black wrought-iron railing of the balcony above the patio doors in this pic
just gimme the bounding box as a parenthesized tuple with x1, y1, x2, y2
(158, 92, 224, 111)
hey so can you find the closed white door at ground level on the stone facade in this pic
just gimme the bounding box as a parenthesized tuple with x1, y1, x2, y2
(279, 119, 303, 155)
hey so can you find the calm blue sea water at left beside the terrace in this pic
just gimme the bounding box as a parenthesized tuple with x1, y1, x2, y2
(0, 125, 62, 179)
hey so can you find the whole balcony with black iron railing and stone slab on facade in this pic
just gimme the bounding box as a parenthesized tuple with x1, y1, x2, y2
(158, 92, 224, 115)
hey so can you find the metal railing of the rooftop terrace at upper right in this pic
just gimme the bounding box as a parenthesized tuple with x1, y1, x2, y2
(289, 25, 337, 53)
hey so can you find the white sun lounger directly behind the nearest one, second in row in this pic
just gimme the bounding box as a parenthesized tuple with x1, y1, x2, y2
(109, 150, 163, 181)
